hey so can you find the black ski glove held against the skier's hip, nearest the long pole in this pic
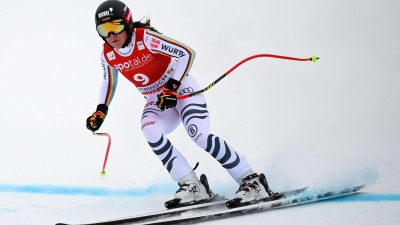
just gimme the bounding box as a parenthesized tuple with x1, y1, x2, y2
(156, 78, 181, 110)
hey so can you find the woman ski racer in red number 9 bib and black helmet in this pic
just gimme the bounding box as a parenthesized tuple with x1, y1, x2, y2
(86, 0, 278, 207)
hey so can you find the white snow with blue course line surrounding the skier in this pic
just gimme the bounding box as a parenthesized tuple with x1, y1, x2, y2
(0, 0, 400, 225)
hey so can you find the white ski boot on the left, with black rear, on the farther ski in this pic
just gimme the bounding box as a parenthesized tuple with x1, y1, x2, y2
(164, 171, 223, 209)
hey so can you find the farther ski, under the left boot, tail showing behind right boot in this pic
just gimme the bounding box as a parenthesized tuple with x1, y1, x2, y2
(56, 187, 307, 225)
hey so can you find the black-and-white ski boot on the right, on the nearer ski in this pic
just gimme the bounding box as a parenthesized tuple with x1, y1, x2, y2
(225, 171, 285, 208)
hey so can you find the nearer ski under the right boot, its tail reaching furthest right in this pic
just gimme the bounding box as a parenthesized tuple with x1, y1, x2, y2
(143, 185, 364, 225)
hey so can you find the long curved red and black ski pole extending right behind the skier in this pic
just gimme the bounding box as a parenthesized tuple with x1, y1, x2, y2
(178, 54, 319, 100)
